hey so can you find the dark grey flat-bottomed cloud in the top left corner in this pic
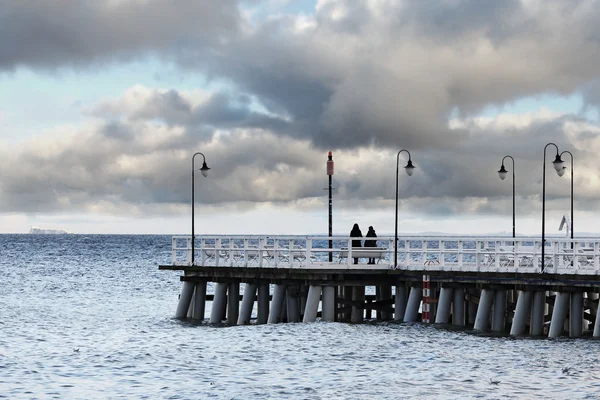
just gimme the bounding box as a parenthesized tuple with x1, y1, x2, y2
(0, 0, 240, 70)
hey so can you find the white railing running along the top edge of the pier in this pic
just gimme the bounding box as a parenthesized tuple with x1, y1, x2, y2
(172, 235, 600, 275)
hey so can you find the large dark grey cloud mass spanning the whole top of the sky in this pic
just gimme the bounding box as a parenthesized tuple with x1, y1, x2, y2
(0, 0, 600, 150)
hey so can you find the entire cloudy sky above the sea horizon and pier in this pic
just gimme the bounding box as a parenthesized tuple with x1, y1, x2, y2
(0, 0, 600, 236)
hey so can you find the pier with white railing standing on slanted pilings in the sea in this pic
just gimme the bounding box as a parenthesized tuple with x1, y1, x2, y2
(159, 235, 600, 338)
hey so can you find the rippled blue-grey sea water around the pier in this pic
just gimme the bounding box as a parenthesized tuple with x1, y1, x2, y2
(0, 235, 600, 399)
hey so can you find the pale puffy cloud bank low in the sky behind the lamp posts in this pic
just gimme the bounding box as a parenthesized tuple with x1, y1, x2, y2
(0, 86, 600, 225)
